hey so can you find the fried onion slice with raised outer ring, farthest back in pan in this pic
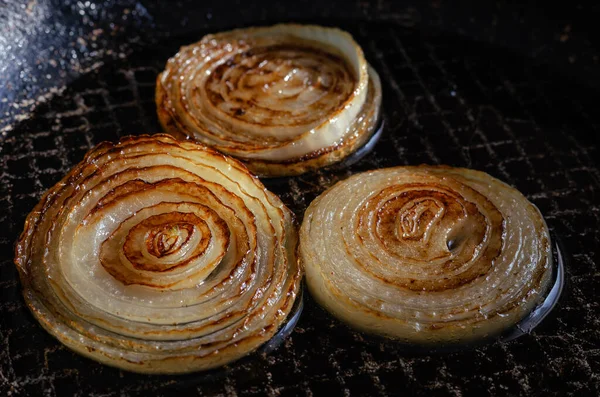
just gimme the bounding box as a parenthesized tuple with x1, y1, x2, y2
(156, 24, 381, 176)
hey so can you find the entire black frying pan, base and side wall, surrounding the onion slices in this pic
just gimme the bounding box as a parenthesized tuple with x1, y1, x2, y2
(0, 0, 600, 396)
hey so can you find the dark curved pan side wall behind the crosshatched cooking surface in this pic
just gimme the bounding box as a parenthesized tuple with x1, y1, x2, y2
(0, 0, 600, 126)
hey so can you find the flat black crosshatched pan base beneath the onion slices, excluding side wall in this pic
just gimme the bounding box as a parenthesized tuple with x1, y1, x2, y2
(0, 24, 600, 396)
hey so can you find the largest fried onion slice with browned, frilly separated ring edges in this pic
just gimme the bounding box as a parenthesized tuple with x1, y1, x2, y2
(15, 135, 301, 373)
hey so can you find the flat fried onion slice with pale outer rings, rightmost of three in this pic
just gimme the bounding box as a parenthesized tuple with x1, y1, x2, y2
(299, 166, 552, 344)
